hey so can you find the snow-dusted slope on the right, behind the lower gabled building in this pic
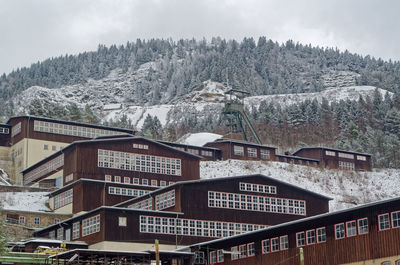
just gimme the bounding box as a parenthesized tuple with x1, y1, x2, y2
(200, 160, 400, 211)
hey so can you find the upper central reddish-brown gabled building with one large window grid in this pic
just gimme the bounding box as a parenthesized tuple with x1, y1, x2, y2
(22, 135, 201, 186)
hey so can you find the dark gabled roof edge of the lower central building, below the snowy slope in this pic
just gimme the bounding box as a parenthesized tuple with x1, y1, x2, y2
(114, 174, 333, 207)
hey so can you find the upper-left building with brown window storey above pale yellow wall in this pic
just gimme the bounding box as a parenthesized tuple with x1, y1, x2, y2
(0, 116, 135, 185)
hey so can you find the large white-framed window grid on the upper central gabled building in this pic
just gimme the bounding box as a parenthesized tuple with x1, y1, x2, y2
(98, 149, 181, 176)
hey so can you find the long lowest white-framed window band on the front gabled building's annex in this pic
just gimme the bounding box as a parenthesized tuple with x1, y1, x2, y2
(140, 215, 266, 238)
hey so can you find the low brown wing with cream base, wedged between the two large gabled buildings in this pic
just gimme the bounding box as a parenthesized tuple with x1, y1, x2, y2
(49, 178, 159, 215)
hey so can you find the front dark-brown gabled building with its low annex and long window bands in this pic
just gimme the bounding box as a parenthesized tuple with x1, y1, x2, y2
(36, 175, 330, 250)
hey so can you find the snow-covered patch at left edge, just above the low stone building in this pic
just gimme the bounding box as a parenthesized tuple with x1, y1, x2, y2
(0, 192, 50, 212)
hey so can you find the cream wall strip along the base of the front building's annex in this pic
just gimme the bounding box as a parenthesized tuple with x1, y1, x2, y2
(89, 241, 184, 251)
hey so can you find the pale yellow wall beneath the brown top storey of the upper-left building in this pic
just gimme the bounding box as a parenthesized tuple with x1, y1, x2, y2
(10, 138, 68, 185)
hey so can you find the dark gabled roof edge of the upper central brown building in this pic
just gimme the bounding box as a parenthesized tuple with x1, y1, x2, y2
(21, 136, 203, 174)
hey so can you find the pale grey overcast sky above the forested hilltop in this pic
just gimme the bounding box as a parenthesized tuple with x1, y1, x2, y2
(0, 0, 400, 73)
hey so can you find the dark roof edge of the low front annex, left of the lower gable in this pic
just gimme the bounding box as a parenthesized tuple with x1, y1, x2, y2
(35, 206, 183, 233)
